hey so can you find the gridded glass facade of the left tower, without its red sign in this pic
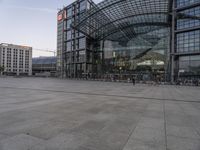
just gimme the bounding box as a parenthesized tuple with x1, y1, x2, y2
(58, 0, 93, 77)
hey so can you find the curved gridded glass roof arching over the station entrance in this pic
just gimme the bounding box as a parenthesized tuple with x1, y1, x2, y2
(74, 0, 171, 40)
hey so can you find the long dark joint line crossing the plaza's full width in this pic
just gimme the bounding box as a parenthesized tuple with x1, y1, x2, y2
(0, 87, 200, 103)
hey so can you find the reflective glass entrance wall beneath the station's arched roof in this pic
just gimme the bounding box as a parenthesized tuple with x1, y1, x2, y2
(103, 28, 170, 74)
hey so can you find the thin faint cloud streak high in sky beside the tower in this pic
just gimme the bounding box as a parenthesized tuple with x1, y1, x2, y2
(3, 5, 57, 13)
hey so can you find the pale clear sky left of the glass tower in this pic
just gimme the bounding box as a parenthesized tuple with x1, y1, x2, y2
(0, 0, 102, 57)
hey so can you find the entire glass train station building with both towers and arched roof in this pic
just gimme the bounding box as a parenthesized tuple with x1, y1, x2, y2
(57, 0, 200, 81)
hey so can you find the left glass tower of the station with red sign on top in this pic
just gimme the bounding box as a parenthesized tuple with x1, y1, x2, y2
(57, 0, 92, 77)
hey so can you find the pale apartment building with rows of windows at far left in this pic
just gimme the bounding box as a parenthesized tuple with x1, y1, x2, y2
(0, 43, 32, 76)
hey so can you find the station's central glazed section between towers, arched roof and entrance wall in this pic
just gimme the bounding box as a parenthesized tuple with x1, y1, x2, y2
(72, 0, 170, 78)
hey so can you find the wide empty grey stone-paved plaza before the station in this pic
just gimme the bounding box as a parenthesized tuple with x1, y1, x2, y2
(0, 78, 200, 150)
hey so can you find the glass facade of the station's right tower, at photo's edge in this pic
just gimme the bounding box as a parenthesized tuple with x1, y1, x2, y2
(175, 0, 200, 79)
